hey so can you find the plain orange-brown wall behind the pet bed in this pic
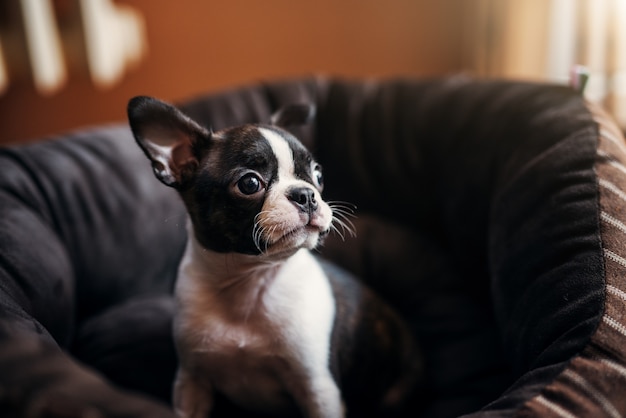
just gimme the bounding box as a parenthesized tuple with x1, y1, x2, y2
(0, 0, 462, 143)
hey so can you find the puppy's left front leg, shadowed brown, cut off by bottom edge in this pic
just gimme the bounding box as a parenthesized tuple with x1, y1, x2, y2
(174, 368, 213, 418)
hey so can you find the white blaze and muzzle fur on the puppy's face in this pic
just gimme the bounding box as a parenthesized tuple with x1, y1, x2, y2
(259, 128, 332, 248)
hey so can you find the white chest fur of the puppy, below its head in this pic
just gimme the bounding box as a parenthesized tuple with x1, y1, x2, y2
(175, 233, 342, 417)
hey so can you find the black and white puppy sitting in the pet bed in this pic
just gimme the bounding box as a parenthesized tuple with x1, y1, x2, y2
(128, 97, 421, 418)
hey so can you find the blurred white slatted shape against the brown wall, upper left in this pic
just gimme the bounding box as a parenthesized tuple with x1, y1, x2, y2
(0, 0, 147, 95)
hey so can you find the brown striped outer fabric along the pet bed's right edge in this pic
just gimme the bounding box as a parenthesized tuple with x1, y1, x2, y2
(519, 104, 626, 418)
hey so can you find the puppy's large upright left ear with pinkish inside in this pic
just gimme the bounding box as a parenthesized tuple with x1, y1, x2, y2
(128, 96, 211, 188)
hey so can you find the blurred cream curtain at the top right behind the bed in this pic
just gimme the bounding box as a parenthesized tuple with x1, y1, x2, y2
(464, 0, 626, 128)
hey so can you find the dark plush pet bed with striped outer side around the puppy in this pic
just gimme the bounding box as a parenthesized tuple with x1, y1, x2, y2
(0, 77, 626, 418)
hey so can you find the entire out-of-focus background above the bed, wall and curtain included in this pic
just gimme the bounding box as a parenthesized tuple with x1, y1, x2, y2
(0, 0, 626, 144)
